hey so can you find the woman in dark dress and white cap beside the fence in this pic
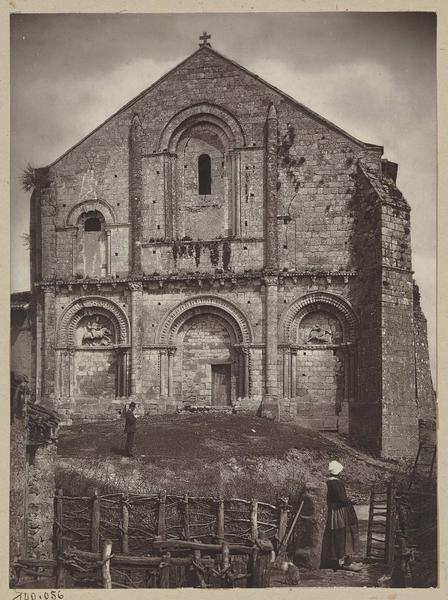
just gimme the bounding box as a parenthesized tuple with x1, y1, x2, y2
(320, 460, 362, 571)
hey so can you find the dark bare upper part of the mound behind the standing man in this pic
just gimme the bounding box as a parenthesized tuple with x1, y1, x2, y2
(58, 413, 334, 461)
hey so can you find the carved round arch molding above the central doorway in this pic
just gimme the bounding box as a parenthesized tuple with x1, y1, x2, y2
(157, 296, 253, 345)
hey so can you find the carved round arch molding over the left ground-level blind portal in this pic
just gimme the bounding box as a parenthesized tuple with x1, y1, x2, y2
(57, 296, 130, 347)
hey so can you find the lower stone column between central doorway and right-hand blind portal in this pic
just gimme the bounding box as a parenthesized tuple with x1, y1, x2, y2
(262, 276, 280, 419)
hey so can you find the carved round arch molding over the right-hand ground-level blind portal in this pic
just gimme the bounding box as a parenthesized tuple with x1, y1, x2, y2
(279, 292, 358, 344)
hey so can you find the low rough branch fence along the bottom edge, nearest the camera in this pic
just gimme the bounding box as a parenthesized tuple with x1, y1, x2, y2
(14, 539, 273, 589)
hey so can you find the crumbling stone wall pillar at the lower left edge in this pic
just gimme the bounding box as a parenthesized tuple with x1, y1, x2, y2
(10, 373, 59, 569)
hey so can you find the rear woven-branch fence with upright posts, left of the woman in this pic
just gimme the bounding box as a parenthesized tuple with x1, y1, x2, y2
(55, 489, 290, 556)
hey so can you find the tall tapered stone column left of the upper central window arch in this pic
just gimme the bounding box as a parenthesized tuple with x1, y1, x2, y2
(129, 115, 143, 275)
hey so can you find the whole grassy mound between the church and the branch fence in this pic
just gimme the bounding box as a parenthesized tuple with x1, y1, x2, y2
(57, 413, 406, 502)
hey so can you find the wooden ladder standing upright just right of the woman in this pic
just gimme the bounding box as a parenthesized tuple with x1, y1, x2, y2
(366, 480, 397, 565)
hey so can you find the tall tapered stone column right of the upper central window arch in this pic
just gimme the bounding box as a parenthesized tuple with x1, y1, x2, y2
(264, 104, 279, 270)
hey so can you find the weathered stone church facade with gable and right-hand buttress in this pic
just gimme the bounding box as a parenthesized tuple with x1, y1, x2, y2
(27, 43, 434, 457)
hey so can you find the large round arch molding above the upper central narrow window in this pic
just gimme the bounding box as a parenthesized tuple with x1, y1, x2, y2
(158, 102, 246, 152)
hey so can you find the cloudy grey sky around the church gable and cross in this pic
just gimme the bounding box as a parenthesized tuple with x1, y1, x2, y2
(11, 13, 436, 370)
